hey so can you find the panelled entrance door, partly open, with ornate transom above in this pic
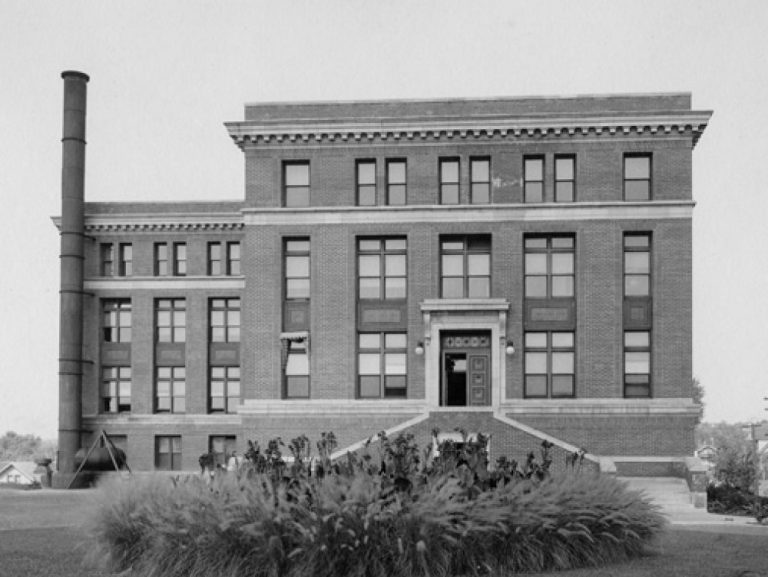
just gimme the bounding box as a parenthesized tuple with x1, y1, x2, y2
(440, 333, 491, 407)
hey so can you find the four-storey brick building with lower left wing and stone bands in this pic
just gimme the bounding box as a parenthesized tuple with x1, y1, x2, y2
(55, 73, 710, 473)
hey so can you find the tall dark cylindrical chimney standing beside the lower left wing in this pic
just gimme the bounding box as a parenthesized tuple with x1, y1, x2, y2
(56, 70, 89, 476)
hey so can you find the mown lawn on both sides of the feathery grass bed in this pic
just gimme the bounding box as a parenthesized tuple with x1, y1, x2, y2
(0, 490, 768, 577)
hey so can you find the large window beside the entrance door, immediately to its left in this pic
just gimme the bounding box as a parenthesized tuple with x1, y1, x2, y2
(357, 333, 408, 399)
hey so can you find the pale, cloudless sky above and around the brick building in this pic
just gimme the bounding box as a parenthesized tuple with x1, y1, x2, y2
(0, 0, 768, 438)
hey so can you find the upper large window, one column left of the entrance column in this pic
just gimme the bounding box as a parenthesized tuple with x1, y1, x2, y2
(357, 238, 407, 300)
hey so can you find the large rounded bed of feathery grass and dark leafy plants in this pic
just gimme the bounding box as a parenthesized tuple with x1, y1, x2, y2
(84, 434, 664, 577)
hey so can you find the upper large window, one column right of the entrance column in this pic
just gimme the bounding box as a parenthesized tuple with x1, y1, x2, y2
(524, 236, 575, 298)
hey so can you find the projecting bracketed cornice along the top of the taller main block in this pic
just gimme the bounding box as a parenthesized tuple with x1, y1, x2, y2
(224, 111, 711, 149)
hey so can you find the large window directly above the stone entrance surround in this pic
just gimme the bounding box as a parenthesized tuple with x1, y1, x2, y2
(440, 235, 491, 298)
